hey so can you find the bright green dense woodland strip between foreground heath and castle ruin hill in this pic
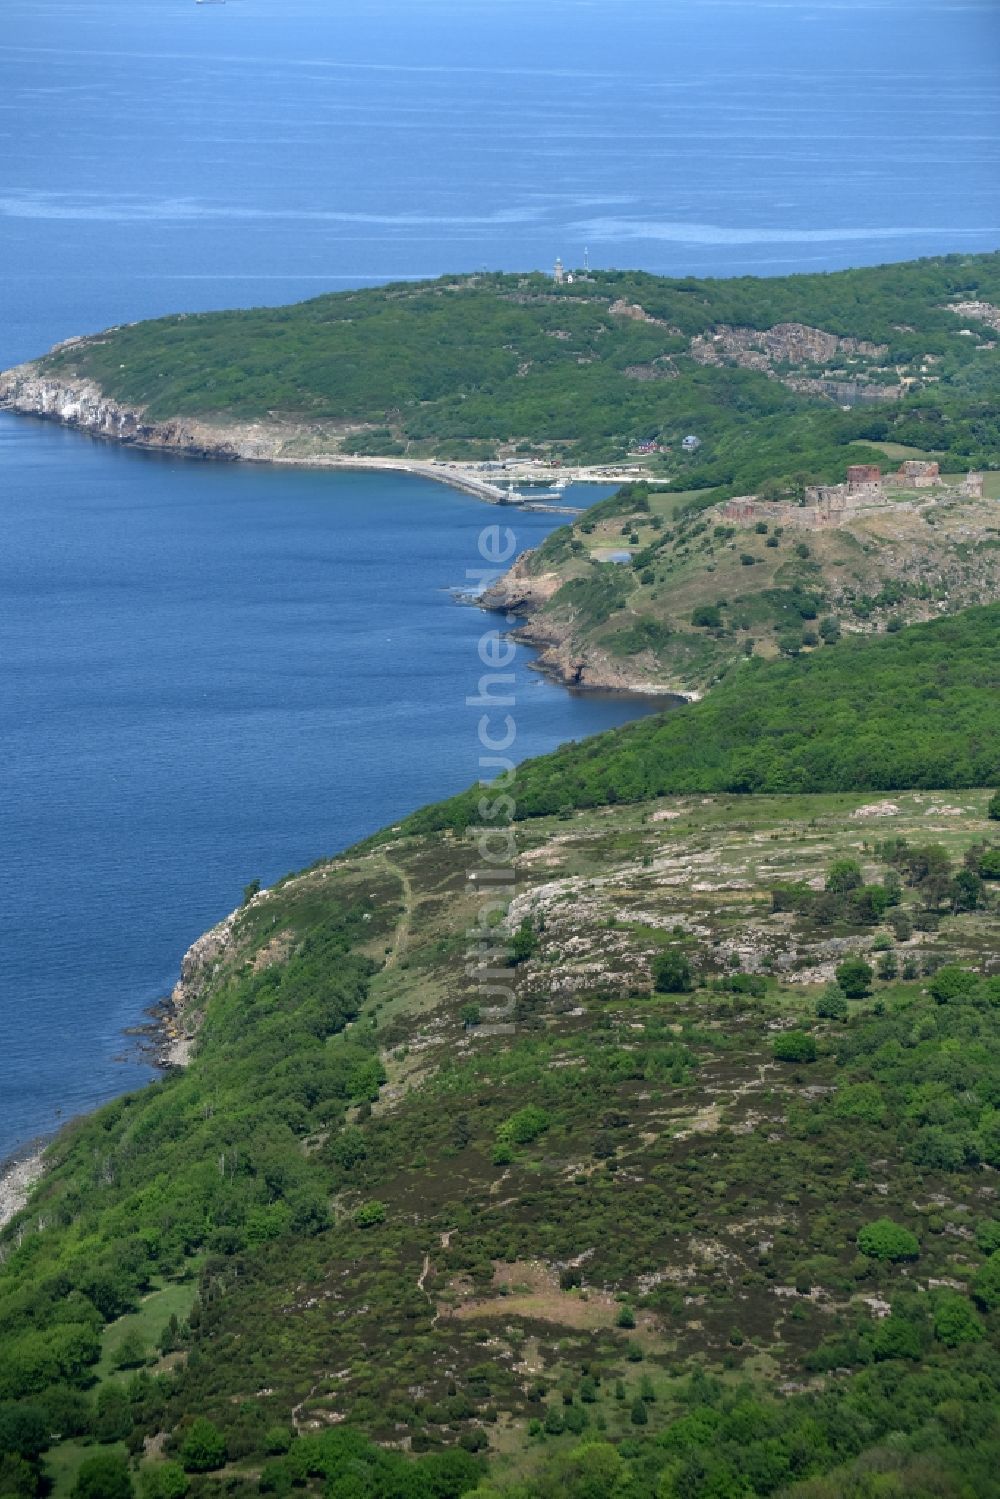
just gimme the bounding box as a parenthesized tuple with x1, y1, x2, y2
(395, 604, 1000, 832)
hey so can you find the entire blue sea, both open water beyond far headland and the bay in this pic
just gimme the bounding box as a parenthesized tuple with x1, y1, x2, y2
(0, 0, 1000, 1157)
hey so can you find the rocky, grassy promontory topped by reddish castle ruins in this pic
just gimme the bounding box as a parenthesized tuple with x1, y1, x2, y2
(484, 474, 1000, 693)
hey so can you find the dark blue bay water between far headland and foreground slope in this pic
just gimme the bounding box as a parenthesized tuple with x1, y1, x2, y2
(0, 417, 665, 1160)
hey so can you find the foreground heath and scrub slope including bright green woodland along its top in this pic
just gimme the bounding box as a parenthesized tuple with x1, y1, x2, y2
(0, 590, 1000, 1499)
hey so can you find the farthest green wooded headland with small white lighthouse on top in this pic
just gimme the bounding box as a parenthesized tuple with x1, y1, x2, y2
(33, 255, 1000, 489)
